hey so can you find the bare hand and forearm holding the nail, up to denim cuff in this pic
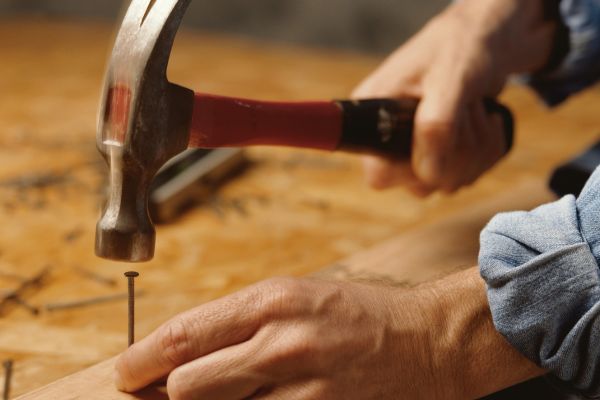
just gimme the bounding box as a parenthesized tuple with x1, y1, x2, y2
(111, 268, 542, 400)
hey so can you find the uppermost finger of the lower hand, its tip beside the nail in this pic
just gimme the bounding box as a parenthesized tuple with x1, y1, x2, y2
(115, 287, 261, 392)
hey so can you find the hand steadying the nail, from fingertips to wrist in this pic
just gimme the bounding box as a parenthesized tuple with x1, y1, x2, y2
(116, 278, 446, 400)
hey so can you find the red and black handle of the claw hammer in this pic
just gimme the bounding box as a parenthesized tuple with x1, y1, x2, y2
(189, 93, 514, 159)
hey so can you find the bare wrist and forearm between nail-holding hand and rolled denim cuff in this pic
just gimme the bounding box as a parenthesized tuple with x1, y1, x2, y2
(417, 268, 544, 399)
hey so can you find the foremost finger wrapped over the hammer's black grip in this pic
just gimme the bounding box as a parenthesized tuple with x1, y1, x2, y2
(412, 67, 465, 187)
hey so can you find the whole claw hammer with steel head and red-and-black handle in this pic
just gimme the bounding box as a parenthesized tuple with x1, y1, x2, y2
(96, 0, 513, 262)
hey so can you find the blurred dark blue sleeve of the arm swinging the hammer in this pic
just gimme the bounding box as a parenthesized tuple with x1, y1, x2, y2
(523, 0, 600, 106)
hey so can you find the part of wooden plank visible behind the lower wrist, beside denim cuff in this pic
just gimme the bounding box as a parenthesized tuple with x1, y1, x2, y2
(316, 181, 554, 286)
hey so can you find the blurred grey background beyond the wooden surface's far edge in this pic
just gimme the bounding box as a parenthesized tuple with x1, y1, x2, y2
(0, 0, 448, 54)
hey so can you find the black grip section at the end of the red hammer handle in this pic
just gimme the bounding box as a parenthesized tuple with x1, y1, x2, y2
(336, 99, 514, 158)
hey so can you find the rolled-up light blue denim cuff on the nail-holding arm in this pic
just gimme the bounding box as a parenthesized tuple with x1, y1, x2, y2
(479, 165, 600, 397)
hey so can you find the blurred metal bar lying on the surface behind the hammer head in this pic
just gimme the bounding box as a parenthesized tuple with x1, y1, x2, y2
(149, 148, 247, 223)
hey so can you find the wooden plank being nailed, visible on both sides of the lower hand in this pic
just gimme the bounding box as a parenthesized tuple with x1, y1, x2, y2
(17, 182, 551, 400)
